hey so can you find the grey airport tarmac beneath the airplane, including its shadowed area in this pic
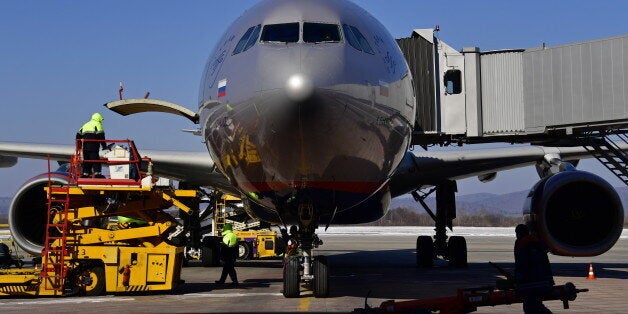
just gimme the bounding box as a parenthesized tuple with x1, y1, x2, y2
(0, 227, 628, 313)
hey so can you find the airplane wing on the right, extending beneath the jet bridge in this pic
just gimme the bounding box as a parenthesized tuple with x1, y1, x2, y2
(390, 145, 628, 197)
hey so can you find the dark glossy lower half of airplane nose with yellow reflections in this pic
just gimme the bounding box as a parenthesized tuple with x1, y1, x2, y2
(205, 88, 411, 217)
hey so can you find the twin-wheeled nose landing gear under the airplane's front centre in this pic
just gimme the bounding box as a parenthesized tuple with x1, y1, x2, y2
(283, 203, 329, 298)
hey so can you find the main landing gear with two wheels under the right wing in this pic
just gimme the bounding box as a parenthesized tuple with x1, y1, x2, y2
(412, 181, 467, 268)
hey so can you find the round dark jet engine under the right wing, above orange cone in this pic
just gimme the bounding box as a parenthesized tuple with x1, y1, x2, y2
(523, 170, 624, 256)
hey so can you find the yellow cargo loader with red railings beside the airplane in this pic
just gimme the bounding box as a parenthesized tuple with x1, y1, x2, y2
(0, 140, 198, 296)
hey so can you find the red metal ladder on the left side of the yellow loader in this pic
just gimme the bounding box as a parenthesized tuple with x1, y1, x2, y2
(41, 161, 71, 291)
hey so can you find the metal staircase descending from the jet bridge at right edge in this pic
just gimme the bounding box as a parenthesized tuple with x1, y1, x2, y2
(579, 130, 628, 185)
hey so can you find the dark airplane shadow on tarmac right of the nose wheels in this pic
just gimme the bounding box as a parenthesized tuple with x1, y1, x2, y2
(328, 250, 628, 299)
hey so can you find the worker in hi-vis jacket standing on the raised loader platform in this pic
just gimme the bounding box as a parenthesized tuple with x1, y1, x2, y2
(76, 112, 107, 178)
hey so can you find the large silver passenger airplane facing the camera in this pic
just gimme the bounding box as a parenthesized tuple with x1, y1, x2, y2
(0, 0, 625, 297)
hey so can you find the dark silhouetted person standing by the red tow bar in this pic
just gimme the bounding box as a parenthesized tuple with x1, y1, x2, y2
(515, 224, 554, 313)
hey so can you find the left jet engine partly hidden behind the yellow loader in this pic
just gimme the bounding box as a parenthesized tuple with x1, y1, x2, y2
(9, 172, 70, 255)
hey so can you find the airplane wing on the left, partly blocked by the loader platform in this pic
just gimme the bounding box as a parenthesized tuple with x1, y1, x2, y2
(0, 142, 237, 194)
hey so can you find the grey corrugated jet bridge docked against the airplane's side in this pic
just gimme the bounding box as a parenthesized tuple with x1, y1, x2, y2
(397, 29, 628, 145)
